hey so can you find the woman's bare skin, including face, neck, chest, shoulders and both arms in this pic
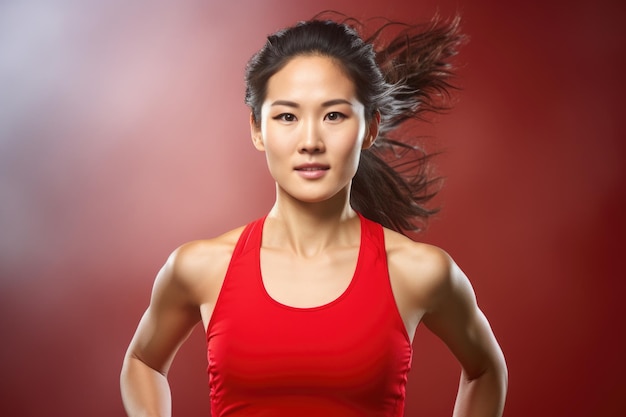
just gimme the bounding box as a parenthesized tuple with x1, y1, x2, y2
(121, 56, 507, 417)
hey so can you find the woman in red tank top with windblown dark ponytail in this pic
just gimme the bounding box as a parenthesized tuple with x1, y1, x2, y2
(121, 13, 507, 417)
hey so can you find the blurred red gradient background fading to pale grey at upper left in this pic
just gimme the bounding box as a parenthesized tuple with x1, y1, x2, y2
(0, 0, 626, 417)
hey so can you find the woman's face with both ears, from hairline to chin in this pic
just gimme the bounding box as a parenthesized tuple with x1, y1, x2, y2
(251, 56, 378, 203)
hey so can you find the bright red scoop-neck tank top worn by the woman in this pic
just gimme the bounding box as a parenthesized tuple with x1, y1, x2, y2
(207, 215, 412, 417)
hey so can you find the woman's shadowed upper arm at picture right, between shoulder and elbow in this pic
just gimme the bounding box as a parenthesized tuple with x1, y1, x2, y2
(423, 259, 503, 378)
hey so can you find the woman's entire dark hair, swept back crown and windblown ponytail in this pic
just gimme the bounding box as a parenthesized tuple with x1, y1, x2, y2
(245, 13, 465, 233)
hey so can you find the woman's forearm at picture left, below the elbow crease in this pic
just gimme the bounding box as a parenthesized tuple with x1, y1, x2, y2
(120, 356, 172, 417)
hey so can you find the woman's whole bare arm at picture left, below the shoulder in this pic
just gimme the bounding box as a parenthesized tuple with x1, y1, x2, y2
(120, 244, 201, 417)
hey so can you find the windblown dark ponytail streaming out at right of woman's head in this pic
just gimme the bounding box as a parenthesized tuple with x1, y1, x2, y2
(350, 17, 466, 233)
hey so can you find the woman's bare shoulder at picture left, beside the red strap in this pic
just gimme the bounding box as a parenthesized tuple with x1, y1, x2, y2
(158, 226, 244, 303)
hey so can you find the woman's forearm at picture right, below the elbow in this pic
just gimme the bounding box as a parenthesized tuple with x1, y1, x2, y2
(453, 364, 507, 417)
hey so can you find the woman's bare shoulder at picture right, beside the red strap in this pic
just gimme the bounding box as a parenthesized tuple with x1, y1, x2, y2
(385, 229, 456, 311)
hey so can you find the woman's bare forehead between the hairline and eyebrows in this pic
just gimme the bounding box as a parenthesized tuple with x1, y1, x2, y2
(266, 55, 355, 99)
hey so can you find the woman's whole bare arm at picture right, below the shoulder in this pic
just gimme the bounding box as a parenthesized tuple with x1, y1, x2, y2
(423, 253, 508, 417)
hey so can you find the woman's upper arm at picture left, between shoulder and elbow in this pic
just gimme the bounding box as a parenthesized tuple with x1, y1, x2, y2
(127, 254, 200, 374)
